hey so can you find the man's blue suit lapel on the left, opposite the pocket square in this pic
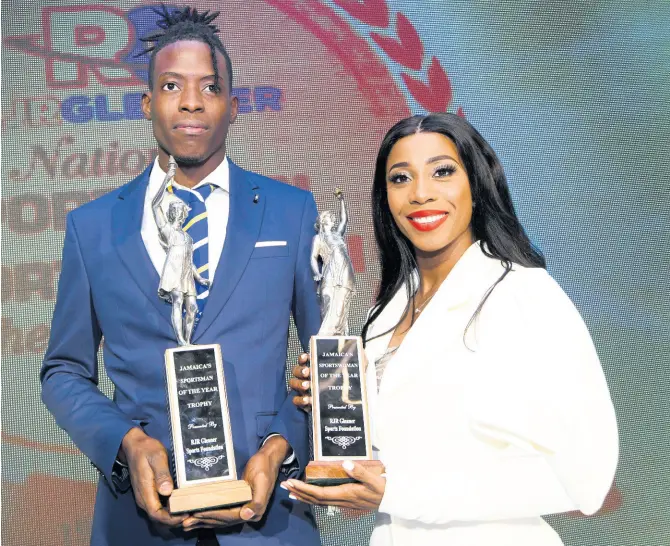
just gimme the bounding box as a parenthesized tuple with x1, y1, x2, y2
(112, 166, 172, 324)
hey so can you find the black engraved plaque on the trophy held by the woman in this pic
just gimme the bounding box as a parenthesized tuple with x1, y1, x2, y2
(311, 337, 371, 460)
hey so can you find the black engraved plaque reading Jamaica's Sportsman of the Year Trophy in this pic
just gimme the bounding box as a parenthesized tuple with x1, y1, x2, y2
(166, 345, 236, 487)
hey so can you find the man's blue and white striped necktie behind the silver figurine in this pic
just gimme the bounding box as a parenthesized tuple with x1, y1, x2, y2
(168, 184, 216, 324)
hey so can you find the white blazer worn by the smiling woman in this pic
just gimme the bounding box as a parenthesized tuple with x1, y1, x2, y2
(366, 243, 618, 546)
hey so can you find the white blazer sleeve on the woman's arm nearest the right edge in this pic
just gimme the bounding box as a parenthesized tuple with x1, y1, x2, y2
(379, 270, 618, 524)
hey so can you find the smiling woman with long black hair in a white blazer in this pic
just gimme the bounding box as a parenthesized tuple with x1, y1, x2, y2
(283, 114, 618, 546)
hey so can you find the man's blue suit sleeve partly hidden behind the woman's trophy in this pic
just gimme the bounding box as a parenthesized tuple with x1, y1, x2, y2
(263, 193, 321, 475)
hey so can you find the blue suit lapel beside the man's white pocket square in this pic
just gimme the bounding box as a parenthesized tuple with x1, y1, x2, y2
(193, 160, 265, 343)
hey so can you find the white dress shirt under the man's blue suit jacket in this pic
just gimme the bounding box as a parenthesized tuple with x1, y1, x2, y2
(142, 157, 230, 282)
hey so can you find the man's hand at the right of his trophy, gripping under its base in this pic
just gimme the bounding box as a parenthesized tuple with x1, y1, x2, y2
(184, 436, 289, 531)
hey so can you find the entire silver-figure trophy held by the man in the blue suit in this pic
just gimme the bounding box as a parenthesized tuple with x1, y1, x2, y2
(151, 156, 251, 514)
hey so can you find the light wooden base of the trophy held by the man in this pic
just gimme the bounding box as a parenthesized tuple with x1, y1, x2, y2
(168, 480, 251, 514)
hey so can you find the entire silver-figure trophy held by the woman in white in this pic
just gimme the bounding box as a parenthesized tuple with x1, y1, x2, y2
(305, 189, 382, 485)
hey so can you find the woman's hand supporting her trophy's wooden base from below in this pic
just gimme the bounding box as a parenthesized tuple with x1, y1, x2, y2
(281, 461, 386, 511)
